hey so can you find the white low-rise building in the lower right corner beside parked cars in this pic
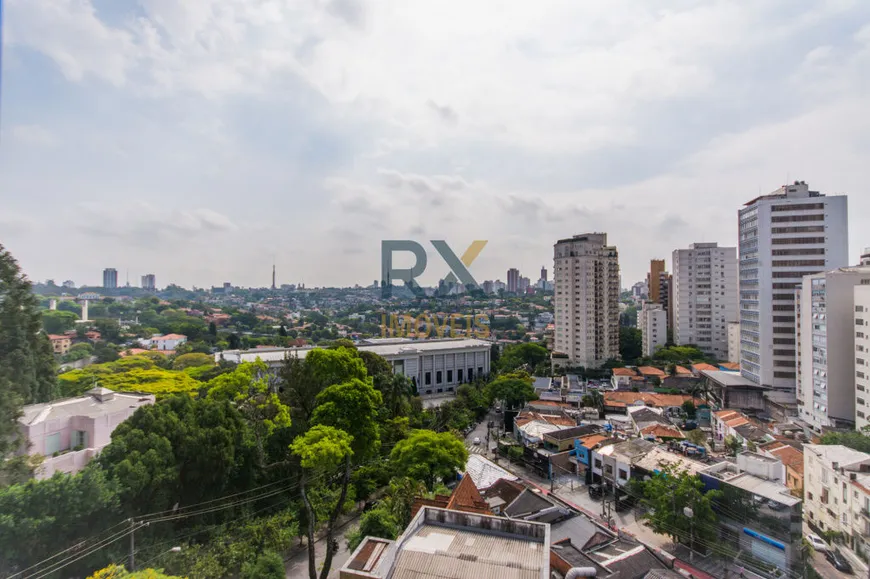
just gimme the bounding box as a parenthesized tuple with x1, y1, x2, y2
(804, 444, 870, 557)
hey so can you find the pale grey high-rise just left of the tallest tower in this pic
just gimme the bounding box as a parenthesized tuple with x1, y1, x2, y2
(672, 243, 737, 360)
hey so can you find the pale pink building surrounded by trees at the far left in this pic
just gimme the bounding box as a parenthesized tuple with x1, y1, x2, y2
(18, 387, 154, 479)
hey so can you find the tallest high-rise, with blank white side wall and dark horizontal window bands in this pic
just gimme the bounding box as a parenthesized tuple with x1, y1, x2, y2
(738, 181, 848, 391)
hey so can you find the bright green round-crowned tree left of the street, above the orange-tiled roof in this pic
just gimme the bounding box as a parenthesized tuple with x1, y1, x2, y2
(390, 430, 468, 490)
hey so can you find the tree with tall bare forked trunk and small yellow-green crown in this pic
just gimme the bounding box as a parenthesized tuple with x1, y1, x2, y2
(290, 424, 353, 579)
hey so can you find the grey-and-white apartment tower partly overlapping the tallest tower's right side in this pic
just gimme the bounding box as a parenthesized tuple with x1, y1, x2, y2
(800, 266, 870, 432)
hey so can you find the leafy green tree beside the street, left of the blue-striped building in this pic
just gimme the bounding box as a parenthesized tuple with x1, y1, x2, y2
(632, 465, 721, 545)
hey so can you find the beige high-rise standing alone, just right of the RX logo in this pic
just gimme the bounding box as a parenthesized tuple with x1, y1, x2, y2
(553, 233, 619, 368)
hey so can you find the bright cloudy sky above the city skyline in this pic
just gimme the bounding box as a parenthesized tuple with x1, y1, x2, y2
(0, 0, 870, 287)
